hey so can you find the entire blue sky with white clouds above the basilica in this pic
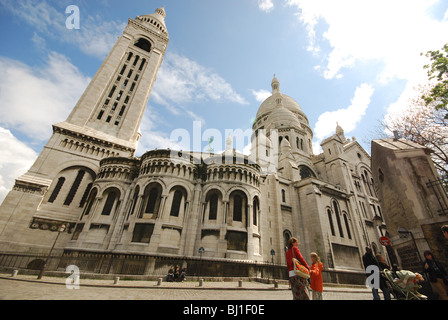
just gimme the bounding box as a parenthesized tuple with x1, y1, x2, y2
(0, 0, 448, 201)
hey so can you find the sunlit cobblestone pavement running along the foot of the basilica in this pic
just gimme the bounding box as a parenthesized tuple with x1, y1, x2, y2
(0, 275, 372, 300)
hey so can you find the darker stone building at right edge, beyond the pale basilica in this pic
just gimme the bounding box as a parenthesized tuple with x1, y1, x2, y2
(372, 138, 448, 272)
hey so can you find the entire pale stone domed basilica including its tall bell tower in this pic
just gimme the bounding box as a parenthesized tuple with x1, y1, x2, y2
(0, 8, 383, 283)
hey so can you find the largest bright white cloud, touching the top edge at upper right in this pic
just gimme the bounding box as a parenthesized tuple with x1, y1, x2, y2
(287, 0, 448, 83)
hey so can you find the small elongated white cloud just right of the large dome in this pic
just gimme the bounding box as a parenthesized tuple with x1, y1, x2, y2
(313, 83, 374, 147)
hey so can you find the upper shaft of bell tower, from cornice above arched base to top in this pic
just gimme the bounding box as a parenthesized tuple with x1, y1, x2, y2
(62, 8, 169, 149)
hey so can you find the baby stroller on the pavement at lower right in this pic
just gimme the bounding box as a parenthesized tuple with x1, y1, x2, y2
(381, 269, 428, 300)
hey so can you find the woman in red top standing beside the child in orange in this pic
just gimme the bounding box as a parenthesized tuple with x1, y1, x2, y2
(286, 237, 310, 300)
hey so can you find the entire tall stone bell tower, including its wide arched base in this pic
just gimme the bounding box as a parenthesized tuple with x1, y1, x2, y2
(0, 8, 169, 252)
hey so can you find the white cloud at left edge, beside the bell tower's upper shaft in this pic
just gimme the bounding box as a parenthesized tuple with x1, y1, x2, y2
(0, 53, 90, 142)
